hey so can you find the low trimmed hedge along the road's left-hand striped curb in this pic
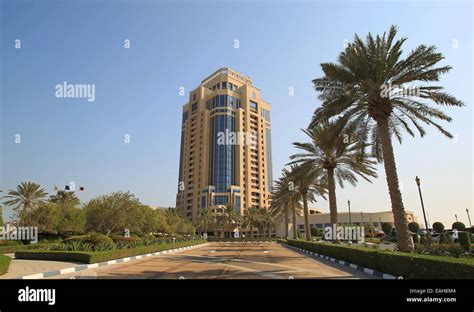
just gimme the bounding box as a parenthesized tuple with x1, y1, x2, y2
(15, 240, 206, 264)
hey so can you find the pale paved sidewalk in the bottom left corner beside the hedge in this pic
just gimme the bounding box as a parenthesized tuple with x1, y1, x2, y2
(0, 254, 79, 279)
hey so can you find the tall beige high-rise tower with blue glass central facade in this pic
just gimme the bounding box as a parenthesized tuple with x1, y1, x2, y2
(176, 68, 272, 221)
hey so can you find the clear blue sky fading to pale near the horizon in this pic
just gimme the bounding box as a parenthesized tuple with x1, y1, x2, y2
(0, 0, 474, 224)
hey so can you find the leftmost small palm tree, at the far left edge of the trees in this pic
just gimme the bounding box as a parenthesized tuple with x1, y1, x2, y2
(4, 182, 48, 225)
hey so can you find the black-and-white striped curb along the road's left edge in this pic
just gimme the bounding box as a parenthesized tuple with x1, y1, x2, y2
(16, 243, 208, 280)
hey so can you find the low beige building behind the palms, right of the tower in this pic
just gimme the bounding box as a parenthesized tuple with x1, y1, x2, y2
(276, 208, 417, 238)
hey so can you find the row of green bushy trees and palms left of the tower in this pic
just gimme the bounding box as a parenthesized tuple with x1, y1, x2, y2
(0, 182, 195, 235)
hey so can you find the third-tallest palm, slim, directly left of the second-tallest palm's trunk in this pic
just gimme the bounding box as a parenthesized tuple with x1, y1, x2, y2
(295, 163, 327, 240)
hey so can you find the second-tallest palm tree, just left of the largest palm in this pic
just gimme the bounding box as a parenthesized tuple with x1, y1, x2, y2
(290, 121, 377, 224)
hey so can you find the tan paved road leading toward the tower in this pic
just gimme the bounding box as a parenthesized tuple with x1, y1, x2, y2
(55, 242, 374, 279)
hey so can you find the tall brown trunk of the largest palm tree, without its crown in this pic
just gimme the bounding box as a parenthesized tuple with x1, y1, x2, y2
(377, 118, 413, 252)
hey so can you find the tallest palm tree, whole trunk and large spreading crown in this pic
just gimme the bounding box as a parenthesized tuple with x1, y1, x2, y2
(310, 26, 463, 252)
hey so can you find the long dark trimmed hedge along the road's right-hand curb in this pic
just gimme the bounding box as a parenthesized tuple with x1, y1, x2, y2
(281, 240, 474, 279)
